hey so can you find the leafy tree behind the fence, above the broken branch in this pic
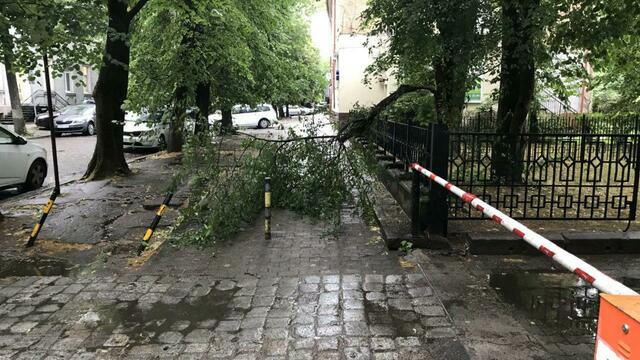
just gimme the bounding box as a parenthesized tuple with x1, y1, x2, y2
(363, 0, 495, 124)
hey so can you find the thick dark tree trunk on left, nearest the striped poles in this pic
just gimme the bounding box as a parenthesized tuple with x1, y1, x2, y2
(84, 0, 131, 180)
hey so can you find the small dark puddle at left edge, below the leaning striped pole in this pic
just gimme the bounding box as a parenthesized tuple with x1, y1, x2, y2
(0, 256, 73, 278)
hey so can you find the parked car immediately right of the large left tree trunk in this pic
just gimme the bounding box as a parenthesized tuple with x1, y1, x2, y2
(122, 112, 169, 150)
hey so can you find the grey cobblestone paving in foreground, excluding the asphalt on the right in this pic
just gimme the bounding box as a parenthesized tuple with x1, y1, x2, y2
(0, 208, 468, 359)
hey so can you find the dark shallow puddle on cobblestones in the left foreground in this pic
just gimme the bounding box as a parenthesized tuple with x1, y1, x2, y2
(87, 289, 237, 350)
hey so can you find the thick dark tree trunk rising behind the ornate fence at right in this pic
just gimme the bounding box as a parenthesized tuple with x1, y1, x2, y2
(492, 0, 539, 182)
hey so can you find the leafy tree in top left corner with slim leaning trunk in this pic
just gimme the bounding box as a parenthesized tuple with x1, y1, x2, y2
(0, 0, 102, 133)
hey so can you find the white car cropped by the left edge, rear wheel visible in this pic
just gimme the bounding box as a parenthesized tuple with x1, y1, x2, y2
(0, 125, 47, 190)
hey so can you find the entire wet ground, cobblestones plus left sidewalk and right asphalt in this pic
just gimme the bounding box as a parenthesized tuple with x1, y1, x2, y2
(0, 123, 640, 359)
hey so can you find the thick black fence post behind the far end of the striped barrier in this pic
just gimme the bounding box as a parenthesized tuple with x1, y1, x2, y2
(425, 124, 449, 236)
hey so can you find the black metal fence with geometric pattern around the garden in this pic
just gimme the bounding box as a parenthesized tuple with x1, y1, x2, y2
(372, 116, 640, 225)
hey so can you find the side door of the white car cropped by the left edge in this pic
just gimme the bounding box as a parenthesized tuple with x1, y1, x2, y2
(0, 127, 29, 186)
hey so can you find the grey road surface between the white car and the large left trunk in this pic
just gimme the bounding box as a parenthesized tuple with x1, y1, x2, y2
(0, 134, 141, 200)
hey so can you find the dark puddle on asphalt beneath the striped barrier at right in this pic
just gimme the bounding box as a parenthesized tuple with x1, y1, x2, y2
(489, 271, 640, 335)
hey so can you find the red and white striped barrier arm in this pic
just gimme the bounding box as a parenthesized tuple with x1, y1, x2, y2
(411, 164, 638, 295)
